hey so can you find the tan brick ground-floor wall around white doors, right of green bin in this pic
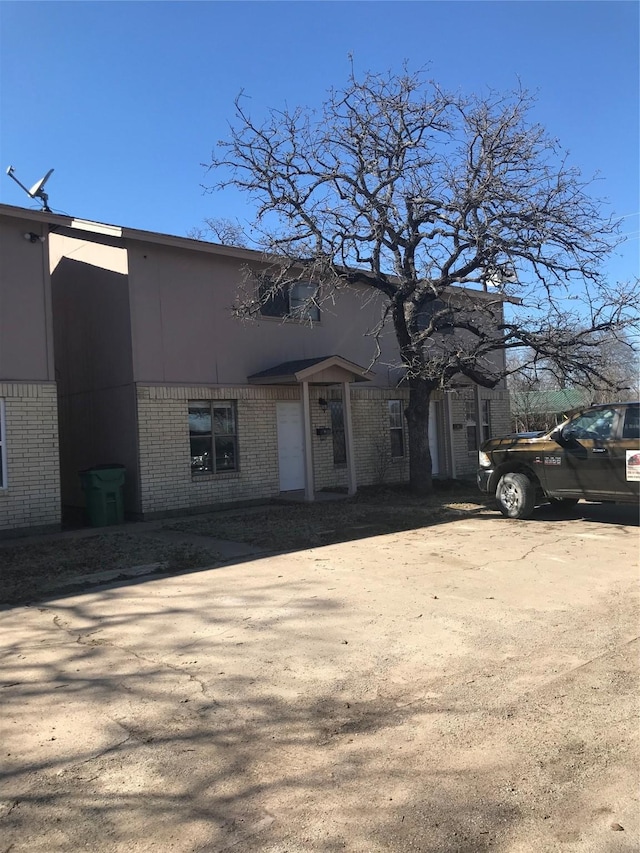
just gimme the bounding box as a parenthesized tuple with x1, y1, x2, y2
(137, 385, 509, 517)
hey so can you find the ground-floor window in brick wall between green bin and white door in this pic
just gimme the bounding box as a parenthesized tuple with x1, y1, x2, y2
(189, 400, 238, 474)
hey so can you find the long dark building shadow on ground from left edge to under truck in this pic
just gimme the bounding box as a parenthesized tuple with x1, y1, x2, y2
(0, 483, 640, 606)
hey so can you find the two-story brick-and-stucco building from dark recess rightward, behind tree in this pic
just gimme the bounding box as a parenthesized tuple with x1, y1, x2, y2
(0, 206, 509, 528)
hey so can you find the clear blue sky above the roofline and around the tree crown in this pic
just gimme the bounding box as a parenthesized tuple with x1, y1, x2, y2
(0, 0, 640, 278)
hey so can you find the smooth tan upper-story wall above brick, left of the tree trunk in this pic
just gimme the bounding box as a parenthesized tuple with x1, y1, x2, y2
(124, 243, 398, 385)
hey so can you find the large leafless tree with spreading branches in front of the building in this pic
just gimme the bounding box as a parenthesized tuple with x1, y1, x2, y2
(209, 69, 637, 492)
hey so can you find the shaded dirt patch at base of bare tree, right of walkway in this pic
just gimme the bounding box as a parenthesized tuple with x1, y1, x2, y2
(163, 487, 487, 551)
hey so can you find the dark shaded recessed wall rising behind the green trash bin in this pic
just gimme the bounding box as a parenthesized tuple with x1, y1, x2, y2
(51, 258, 139, 518)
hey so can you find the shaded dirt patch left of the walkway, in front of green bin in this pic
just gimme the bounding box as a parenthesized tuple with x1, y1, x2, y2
(0, 533, 220, 604)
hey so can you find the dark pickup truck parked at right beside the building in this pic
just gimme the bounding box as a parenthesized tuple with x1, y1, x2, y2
(477, 402, 640, 518)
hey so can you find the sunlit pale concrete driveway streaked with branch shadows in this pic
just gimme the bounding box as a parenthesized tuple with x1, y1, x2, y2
(0, 507, 640, 853)
